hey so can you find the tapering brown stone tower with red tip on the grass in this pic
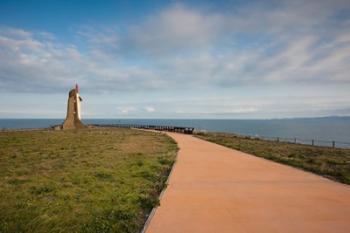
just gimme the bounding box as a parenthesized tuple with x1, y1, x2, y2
(62, 84, 85, 129)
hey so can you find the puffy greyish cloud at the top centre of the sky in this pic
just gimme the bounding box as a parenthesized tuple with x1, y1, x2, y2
(126, 4, 223, 56)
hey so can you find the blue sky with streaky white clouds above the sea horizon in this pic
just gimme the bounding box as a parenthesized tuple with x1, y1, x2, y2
(0, 0, 350, 119)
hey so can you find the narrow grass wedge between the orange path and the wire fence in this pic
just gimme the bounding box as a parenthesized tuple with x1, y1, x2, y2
(196, 133, 350, 184)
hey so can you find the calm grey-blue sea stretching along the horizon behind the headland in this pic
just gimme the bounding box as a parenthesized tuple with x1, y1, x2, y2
(0, 116, 350, 148)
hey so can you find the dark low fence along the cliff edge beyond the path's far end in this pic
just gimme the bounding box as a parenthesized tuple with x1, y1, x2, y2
(93, 124, 194, 134)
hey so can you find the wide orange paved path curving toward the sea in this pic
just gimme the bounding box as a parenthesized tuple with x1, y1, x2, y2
(146, 133, 350, 233)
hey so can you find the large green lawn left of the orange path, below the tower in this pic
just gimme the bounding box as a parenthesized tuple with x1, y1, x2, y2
(0, 128, 177, 233)
